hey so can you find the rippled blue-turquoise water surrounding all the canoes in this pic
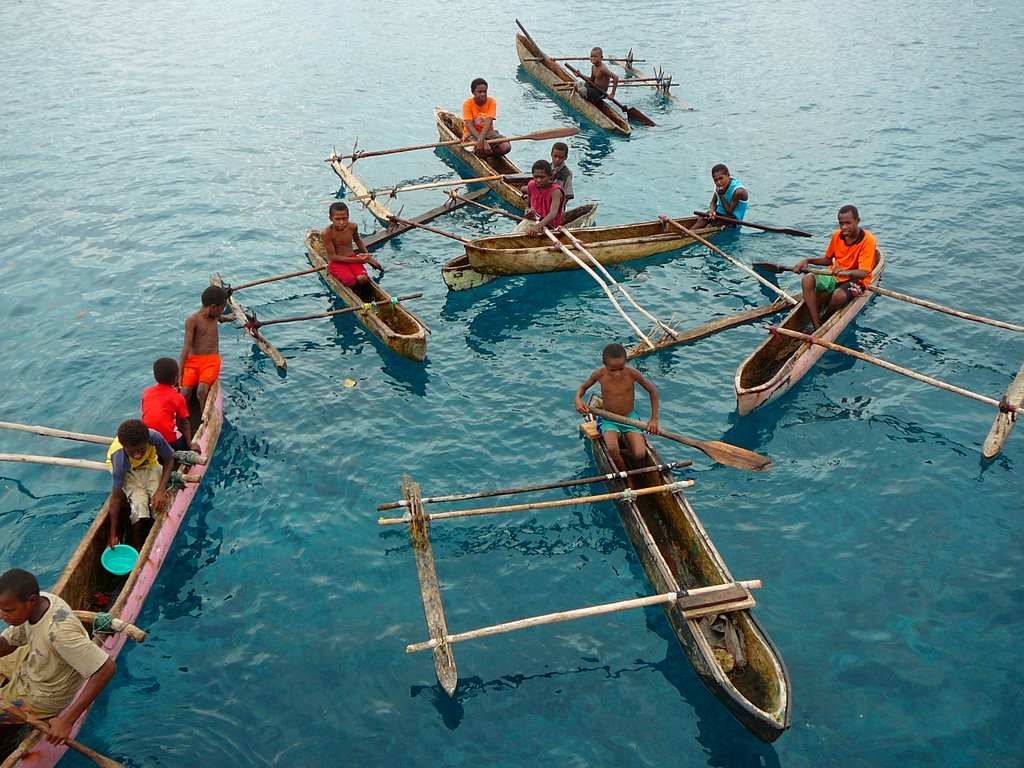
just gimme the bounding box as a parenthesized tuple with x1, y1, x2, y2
(0, 0, 1024, 767)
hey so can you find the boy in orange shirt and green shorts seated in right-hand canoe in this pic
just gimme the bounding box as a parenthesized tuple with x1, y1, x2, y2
(793, 206, 879, 329)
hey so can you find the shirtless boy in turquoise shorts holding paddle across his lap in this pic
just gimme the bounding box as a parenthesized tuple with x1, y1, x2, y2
(575, 344, 657, 487)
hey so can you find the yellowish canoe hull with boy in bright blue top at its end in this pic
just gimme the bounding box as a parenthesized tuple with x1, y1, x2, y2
(466, 216, 723, 274)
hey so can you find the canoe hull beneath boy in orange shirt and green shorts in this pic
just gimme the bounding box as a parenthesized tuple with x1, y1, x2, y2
(733, 249, 886, 416)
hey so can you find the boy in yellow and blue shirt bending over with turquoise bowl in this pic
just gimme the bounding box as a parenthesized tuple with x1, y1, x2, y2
(106, 419, 174, 549)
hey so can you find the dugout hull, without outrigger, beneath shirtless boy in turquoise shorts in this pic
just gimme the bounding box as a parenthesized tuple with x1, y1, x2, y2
(584, 398, 792, 742)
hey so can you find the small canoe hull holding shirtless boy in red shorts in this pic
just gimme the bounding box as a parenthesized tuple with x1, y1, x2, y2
(305, 229, 427, 361)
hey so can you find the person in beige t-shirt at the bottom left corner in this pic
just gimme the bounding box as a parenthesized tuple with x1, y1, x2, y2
(0, 568, 117, 744)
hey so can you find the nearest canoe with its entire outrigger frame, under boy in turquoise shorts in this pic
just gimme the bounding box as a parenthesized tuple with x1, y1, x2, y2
(377, 411, 791, 741)
